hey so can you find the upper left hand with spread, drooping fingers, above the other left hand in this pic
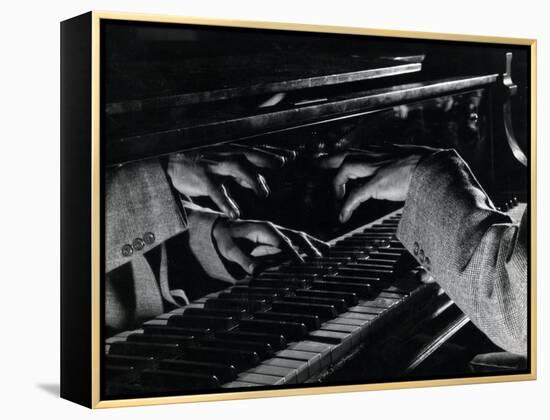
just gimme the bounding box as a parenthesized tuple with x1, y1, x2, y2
(167, 144, 296, 218)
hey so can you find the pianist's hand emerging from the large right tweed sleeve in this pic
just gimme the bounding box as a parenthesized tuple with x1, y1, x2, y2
(320, 145, 437, 223)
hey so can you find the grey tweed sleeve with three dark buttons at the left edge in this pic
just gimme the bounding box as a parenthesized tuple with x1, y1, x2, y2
(105, 160, 187, 272)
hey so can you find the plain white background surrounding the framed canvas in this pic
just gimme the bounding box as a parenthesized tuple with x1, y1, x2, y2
(0, 0, 550, 420)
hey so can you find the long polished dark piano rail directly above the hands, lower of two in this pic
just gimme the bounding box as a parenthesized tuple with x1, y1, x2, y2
(107, 74, 498, 164)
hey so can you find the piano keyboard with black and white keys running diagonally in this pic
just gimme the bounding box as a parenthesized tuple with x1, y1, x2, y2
(104, 199, 528, 395)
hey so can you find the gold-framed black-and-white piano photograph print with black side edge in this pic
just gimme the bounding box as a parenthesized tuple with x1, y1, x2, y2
(61, 12, 536, 408)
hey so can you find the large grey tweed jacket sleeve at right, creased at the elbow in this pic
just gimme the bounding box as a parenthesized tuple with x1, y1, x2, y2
(397, 150, 529, 355)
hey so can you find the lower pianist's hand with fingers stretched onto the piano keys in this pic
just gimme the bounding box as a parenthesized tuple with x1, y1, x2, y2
(212, 218, 328, 274)
